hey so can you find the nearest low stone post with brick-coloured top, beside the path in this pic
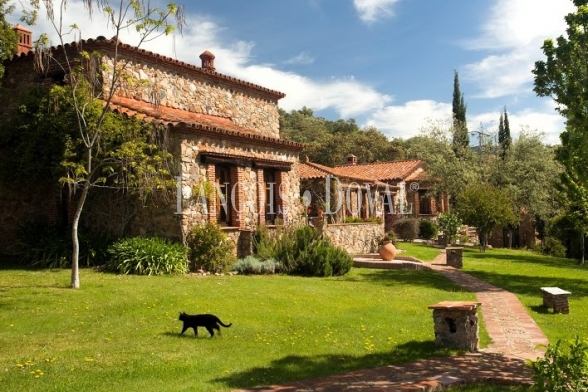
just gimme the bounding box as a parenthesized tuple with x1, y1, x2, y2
(429, 301, 482, 351)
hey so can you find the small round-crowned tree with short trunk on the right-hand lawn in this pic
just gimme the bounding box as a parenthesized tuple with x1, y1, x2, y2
(457, 184, 519, 251)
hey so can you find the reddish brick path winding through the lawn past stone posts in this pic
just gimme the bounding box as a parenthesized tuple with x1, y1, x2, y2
(240, 253, 548, 392)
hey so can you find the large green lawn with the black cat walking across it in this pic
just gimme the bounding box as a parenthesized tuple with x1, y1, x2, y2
(0, 269, 474, 392)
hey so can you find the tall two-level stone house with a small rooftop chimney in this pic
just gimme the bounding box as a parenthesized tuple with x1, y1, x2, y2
(0, 31, 303, 254)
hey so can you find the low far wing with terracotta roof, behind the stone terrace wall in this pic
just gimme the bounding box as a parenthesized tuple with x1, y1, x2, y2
(300, 155, 449, 230)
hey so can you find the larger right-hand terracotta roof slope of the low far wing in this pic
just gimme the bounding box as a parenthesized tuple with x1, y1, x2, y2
(335, 160, 424, 181)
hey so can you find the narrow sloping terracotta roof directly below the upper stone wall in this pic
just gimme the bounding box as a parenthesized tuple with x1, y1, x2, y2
(110, 96, 304, 151)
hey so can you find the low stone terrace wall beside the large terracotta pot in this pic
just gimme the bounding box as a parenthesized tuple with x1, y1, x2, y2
(323, 223, 384, 254)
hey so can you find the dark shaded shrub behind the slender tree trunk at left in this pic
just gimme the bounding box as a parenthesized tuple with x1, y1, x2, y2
(15, 219, 114, 268)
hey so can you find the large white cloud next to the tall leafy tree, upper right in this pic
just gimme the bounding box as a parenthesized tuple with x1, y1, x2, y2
(460, 0, 574, 98)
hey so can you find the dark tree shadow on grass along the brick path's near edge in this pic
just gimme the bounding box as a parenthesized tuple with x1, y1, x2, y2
(212, 341, 450, 389)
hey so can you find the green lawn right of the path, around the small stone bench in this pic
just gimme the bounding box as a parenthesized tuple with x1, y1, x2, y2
(463, 248, 588, 342)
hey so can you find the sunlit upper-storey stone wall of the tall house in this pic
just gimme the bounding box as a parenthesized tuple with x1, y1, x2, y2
(102, 55, 280, 137)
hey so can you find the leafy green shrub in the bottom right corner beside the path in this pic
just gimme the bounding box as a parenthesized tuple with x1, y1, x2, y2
(531, 336, 588, 392)
